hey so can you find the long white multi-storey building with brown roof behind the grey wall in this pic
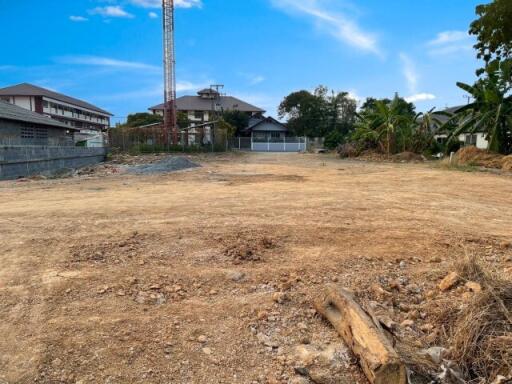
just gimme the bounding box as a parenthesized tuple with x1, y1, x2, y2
(0, 83, 113, 147)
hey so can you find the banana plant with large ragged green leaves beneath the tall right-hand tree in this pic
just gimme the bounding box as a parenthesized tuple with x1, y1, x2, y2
(445, 62, 512, 154)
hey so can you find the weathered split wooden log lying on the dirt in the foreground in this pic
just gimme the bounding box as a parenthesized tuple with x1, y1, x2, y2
(315, 285, 407, 384)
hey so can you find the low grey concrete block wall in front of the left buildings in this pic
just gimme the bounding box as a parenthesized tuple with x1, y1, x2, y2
(0, 145, 107, 180)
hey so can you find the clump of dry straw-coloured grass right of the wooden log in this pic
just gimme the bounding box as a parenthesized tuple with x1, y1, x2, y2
(449, 257, 512, 382)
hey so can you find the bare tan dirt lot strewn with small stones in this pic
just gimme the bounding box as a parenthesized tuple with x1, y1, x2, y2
(0, 154, 512, 384)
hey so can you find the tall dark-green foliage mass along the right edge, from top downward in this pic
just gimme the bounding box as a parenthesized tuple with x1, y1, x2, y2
(443, 0, 512, 154)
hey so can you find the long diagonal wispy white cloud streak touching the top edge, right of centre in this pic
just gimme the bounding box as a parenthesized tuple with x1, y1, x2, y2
(271, 0, 381, 55)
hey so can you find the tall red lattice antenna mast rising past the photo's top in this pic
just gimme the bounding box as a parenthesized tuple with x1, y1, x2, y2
(162, 0, 179, 145)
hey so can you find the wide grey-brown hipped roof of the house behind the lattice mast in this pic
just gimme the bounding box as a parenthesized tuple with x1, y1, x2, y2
(149, 96, 265, 113)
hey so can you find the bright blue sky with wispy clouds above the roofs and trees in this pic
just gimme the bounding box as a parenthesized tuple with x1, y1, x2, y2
(0, 0, 487, 121)
